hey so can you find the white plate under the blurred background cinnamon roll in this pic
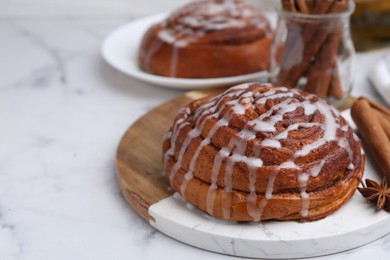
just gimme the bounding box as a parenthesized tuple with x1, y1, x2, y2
(101, 13, 269, 89)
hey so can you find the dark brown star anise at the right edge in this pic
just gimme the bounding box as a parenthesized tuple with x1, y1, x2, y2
(358, 177, 390, 212)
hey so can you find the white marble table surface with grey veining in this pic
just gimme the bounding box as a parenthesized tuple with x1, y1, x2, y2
(0, 7, 390, 260)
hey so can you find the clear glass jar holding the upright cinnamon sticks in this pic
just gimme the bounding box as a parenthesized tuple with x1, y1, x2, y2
(271, 1, 355, 108)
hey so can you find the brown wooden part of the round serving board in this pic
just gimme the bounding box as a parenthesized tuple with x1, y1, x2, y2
(116, 88, 223, 221)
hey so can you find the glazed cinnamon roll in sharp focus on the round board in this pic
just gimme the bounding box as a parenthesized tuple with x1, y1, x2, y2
(163, 83, 364, 221)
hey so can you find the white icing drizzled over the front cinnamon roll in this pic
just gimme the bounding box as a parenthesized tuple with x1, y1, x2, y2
(165, 83, 354, 221)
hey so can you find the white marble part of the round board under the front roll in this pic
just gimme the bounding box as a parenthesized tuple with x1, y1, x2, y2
(149, 111, 390, 259)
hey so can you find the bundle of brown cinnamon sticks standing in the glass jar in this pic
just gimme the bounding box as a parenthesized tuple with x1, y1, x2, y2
(277, 0, 350, 103)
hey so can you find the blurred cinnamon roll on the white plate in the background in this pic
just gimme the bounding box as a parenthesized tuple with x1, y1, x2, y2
(138, 0, 272, 78)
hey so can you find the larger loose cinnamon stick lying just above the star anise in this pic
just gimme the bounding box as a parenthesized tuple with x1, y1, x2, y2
(351, 99, 390, 181)
